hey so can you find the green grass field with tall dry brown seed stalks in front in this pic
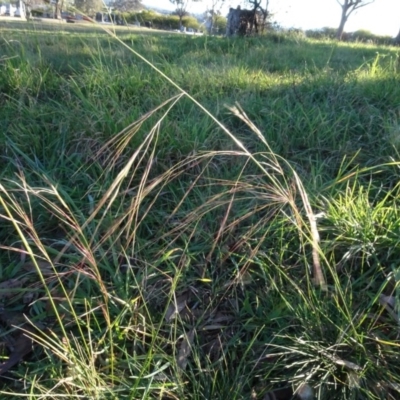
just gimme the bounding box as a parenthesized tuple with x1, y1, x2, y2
(0, 18, 400, 400)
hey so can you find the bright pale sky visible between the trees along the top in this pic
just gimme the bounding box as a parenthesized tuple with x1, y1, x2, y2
(142, 0, 400, 36)
